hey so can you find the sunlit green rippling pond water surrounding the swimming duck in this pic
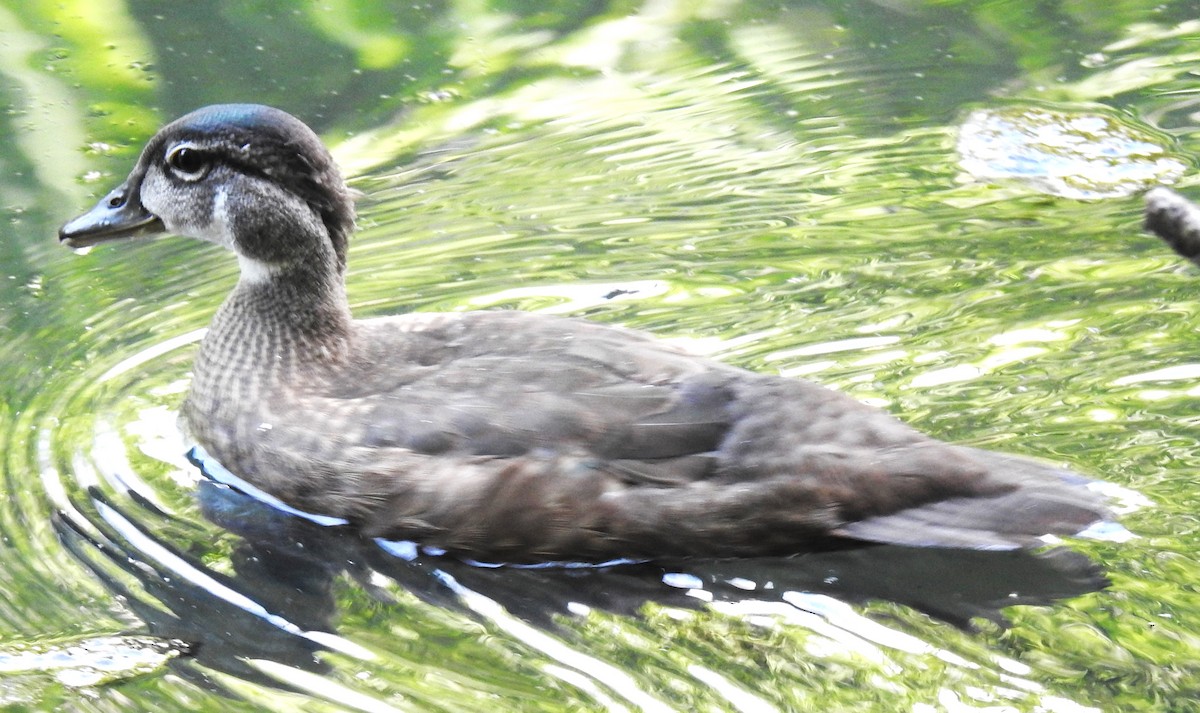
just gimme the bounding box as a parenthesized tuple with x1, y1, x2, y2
(0, 0, 1200, 711)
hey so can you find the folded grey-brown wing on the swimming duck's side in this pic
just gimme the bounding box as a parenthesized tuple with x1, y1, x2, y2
(319, 312, 743, 475)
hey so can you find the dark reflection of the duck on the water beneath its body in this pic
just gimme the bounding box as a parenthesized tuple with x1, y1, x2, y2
(56, 460, 1106, 693)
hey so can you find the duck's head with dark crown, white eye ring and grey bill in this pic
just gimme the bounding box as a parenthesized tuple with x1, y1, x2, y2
(59, 104, 354, 268)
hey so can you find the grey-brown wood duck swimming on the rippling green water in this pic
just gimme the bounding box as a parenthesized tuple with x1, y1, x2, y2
(59, 104, 1110, 562)
